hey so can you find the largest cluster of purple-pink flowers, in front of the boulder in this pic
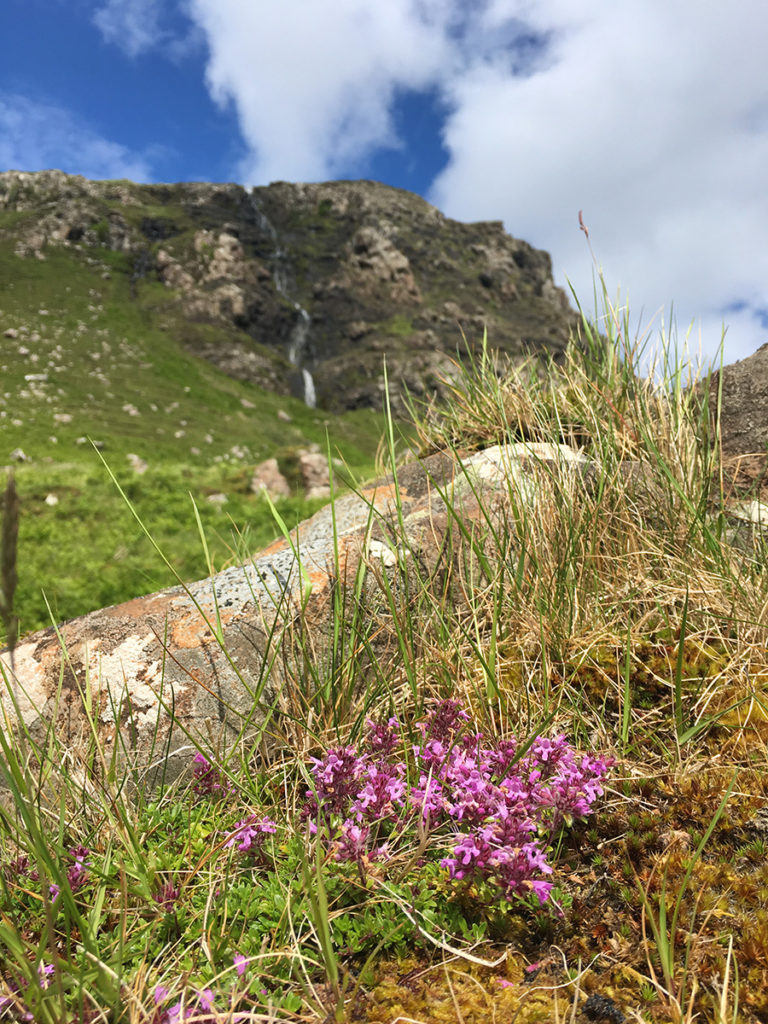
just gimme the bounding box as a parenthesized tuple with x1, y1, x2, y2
(303, 700, 609, 903)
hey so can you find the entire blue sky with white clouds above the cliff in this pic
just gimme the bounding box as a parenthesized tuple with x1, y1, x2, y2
(0, 0, 768, 361)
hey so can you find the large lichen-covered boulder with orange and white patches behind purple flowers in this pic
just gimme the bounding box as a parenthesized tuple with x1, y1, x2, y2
(0, 443, 590, 787)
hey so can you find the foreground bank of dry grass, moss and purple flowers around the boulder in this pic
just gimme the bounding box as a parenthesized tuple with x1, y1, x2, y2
(0, 276, 768, 1024)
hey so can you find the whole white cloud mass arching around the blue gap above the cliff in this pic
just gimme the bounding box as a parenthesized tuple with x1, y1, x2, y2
(182, 0, 768, 368)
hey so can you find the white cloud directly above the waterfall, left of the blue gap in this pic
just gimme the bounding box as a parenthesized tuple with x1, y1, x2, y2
(189, 0, 460, 183)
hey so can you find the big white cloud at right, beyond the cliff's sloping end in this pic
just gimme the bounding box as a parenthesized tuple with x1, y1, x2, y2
(432, 0, 768, 361)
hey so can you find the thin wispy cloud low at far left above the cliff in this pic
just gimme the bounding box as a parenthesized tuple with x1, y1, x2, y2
(0, 93, 152, 181)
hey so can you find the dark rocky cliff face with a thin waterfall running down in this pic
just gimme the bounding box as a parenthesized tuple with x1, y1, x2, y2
(0, 171, 575, 410)
